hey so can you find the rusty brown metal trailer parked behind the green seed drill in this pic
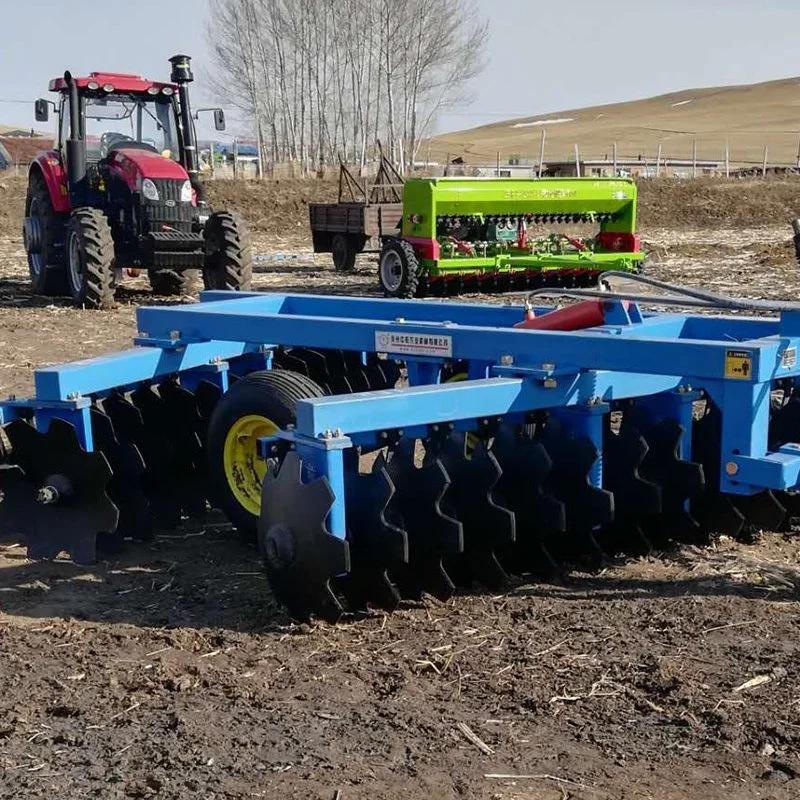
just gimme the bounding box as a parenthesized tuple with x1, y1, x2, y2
(308, 157, 403, 270)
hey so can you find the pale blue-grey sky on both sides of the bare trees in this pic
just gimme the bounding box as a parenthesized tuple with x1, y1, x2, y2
(0, 0, 800, 136)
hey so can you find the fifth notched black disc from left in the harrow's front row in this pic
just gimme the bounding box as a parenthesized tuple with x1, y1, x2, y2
(491, 425, 567, 573)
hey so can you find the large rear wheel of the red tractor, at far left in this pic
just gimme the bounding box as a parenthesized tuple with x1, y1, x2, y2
(23, 172, 67, 297)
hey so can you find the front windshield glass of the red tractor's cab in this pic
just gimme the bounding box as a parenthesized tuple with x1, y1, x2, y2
(85, 94, 179, 161)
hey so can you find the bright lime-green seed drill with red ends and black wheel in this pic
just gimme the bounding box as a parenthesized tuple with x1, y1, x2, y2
(378, 178, 644, 297)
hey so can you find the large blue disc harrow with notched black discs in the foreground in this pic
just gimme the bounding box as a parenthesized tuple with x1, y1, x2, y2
(0, 275, 800, 619)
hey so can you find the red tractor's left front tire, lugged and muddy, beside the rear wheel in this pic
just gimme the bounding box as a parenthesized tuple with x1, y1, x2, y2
(66, 208, 114, 309)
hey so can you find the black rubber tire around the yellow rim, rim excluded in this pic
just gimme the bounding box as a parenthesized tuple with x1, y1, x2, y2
(206, 370, 325, 543)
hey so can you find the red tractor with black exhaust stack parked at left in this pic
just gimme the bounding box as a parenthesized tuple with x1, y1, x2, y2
(23, 55, 252, 308)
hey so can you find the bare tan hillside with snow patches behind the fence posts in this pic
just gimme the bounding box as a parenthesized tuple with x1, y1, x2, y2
(431, 78, 800, 164)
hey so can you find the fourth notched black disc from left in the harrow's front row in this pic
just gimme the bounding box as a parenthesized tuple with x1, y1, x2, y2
(435, 433, 516, 590)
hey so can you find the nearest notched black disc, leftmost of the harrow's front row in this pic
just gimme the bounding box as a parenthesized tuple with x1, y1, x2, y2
(258, 451, 350, 622)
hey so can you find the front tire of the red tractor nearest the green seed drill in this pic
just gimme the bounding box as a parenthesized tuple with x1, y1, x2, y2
(203, 211, 253, 291)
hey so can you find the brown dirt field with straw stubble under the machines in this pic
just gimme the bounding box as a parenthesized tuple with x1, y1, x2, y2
(0, 172, 800, 800)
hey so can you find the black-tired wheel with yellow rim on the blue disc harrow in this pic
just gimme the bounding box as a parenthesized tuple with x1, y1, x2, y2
(207, 370, 323, 542)
